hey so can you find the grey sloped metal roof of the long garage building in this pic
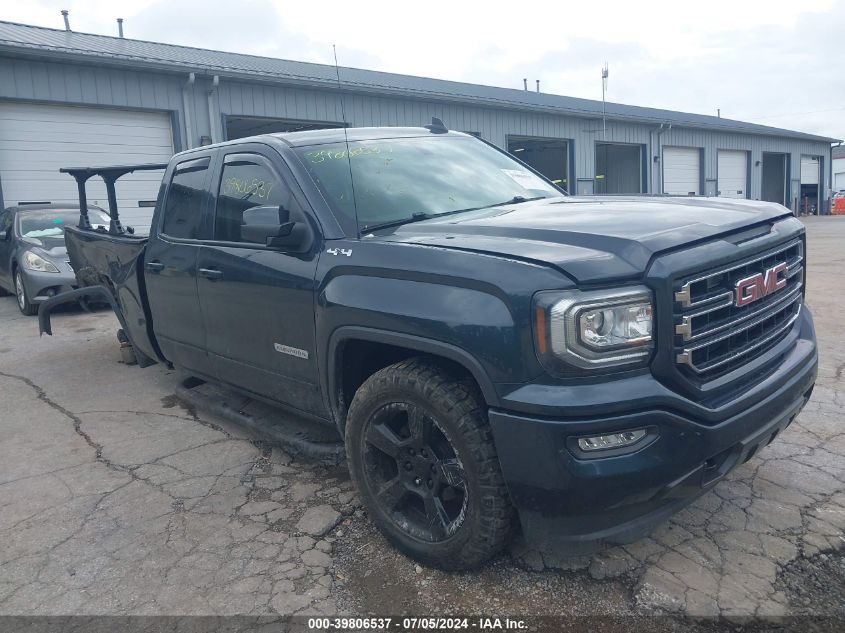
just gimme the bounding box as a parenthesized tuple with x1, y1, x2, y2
(0, 21, 832, 142)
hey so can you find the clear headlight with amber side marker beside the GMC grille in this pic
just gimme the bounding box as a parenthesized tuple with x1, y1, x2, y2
(534, 286, 653, 374)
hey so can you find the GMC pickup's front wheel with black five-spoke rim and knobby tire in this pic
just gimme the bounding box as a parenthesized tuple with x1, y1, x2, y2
(346, 359, 514, 570)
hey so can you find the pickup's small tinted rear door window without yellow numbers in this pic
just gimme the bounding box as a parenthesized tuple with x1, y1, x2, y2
(161, 157, 210, 239)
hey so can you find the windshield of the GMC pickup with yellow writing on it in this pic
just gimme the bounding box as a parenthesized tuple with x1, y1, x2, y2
(296, 136, 563, 230)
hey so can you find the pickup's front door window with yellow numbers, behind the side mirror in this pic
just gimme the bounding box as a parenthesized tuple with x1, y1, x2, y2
(214, 159, 299, 242)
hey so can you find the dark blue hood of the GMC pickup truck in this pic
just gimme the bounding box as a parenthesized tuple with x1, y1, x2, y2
(376, 196, 791, 282)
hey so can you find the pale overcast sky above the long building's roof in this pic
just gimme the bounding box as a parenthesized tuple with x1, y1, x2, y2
(0, 0, 845, 138)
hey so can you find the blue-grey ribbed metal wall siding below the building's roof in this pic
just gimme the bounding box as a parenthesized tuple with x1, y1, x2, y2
(0, 57, 830, 205)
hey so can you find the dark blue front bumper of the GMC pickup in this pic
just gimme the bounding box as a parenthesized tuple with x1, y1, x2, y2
(489, 309, 818, 555)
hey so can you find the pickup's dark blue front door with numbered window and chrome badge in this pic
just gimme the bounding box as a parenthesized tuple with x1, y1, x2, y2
(197, 145, 326, 416)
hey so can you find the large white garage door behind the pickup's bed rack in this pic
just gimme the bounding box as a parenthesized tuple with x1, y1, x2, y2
(0, 102, 173, 232)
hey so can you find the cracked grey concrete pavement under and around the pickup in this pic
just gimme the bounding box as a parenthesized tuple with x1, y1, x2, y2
(0, 217, 845, 616)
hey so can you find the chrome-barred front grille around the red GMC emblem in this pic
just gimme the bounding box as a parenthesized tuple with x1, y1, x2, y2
(673, 240, 804, 380)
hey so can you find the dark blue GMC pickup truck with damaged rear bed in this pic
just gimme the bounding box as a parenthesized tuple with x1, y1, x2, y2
(41, 121, 817, 569)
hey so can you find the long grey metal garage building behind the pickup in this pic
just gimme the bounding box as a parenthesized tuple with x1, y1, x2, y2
(0, 22, 835, 231)
